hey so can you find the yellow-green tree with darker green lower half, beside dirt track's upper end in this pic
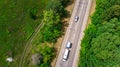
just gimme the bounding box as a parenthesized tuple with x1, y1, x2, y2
(41, 10, 62, 42)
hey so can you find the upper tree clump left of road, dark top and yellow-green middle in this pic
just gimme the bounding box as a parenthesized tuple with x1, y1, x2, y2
(40, 0, 67, 43)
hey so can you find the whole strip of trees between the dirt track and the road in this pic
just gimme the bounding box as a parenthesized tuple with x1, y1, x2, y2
(33, 0, 69, 67)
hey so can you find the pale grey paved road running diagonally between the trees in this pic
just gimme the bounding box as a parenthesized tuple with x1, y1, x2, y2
(55, 0, 92, 67)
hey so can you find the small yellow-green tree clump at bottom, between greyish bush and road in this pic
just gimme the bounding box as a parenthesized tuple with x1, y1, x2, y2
(38, 45, 55, 67)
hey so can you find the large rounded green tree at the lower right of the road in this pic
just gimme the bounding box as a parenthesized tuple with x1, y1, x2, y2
(90, 32, 120, 67)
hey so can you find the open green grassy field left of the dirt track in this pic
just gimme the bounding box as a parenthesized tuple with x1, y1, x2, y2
(0, 0, 48, 67)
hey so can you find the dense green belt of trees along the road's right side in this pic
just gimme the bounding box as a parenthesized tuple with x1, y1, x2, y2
(79, 0, 120, 67)
